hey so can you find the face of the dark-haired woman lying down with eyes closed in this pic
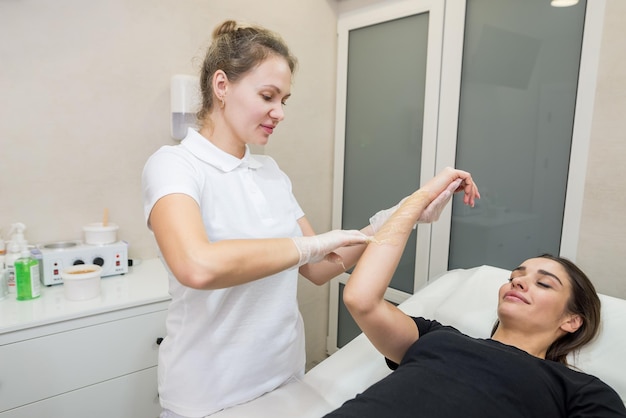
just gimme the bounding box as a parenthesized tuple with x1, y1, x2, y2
(498, 258, 572, 334)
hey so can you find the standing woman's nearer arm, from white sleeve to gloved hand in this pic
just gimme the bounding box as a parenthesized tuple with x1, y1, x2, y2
(149, 193, 365, 289)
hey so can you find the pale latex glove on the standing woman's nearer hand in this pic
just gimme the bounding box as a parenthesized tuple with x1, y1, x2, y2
(291, 229, 368, 267)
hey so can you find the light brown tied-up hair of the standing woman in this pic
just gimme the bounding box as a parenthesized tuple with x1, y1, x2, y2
(197, 20, 297, 123)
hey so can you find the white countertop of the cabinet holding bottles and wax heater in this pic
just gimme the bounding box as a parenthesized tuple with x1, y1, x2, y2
(0, 258, 170, 337)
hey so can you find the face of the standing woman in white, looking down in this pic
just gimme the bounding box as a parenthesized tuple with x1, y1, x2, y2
(224, 56, 291, 145)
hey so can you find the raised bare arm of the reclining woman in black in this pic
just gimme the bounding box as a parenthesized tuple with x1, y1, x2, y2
(343, 168, 480, 363)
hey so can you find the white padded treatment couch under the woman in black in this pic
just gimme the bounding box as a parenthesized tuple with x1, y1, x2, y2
(211, 266, 626, 418)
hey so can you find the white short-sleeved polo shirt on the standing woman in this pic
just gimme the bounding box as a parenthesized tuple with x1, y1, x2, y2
(143, 129, 305, 417)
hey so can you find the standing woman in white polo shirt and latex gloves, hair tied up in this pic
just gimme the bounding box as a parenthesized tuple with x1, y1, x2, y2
(143, 21, 458, 418)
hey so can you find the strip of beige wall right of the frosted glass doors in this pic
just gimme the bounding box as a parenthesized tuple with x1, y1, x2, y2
(572, 0, 626, 298)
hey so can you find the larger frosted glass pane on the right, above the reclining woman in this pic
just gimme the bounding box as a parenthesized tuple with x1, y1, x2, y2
(448, 0, 586, 269)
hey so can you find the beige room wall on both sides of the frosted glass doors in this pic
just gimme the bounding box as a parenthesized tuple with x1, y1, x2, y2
(0, 0, 626, 370)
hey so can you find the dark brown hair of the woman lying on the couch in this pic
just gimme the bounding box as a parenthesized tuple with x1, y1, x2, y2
(491, 254, 601, 365)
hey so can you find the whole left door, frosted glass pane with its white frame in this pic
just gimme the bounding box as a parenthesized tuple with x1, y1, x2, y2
(328, 0, 444, 352)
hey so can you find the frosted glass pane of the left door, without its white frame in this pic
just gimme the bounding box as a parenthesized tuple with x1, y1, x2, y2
(341, 13, 428, 293)
